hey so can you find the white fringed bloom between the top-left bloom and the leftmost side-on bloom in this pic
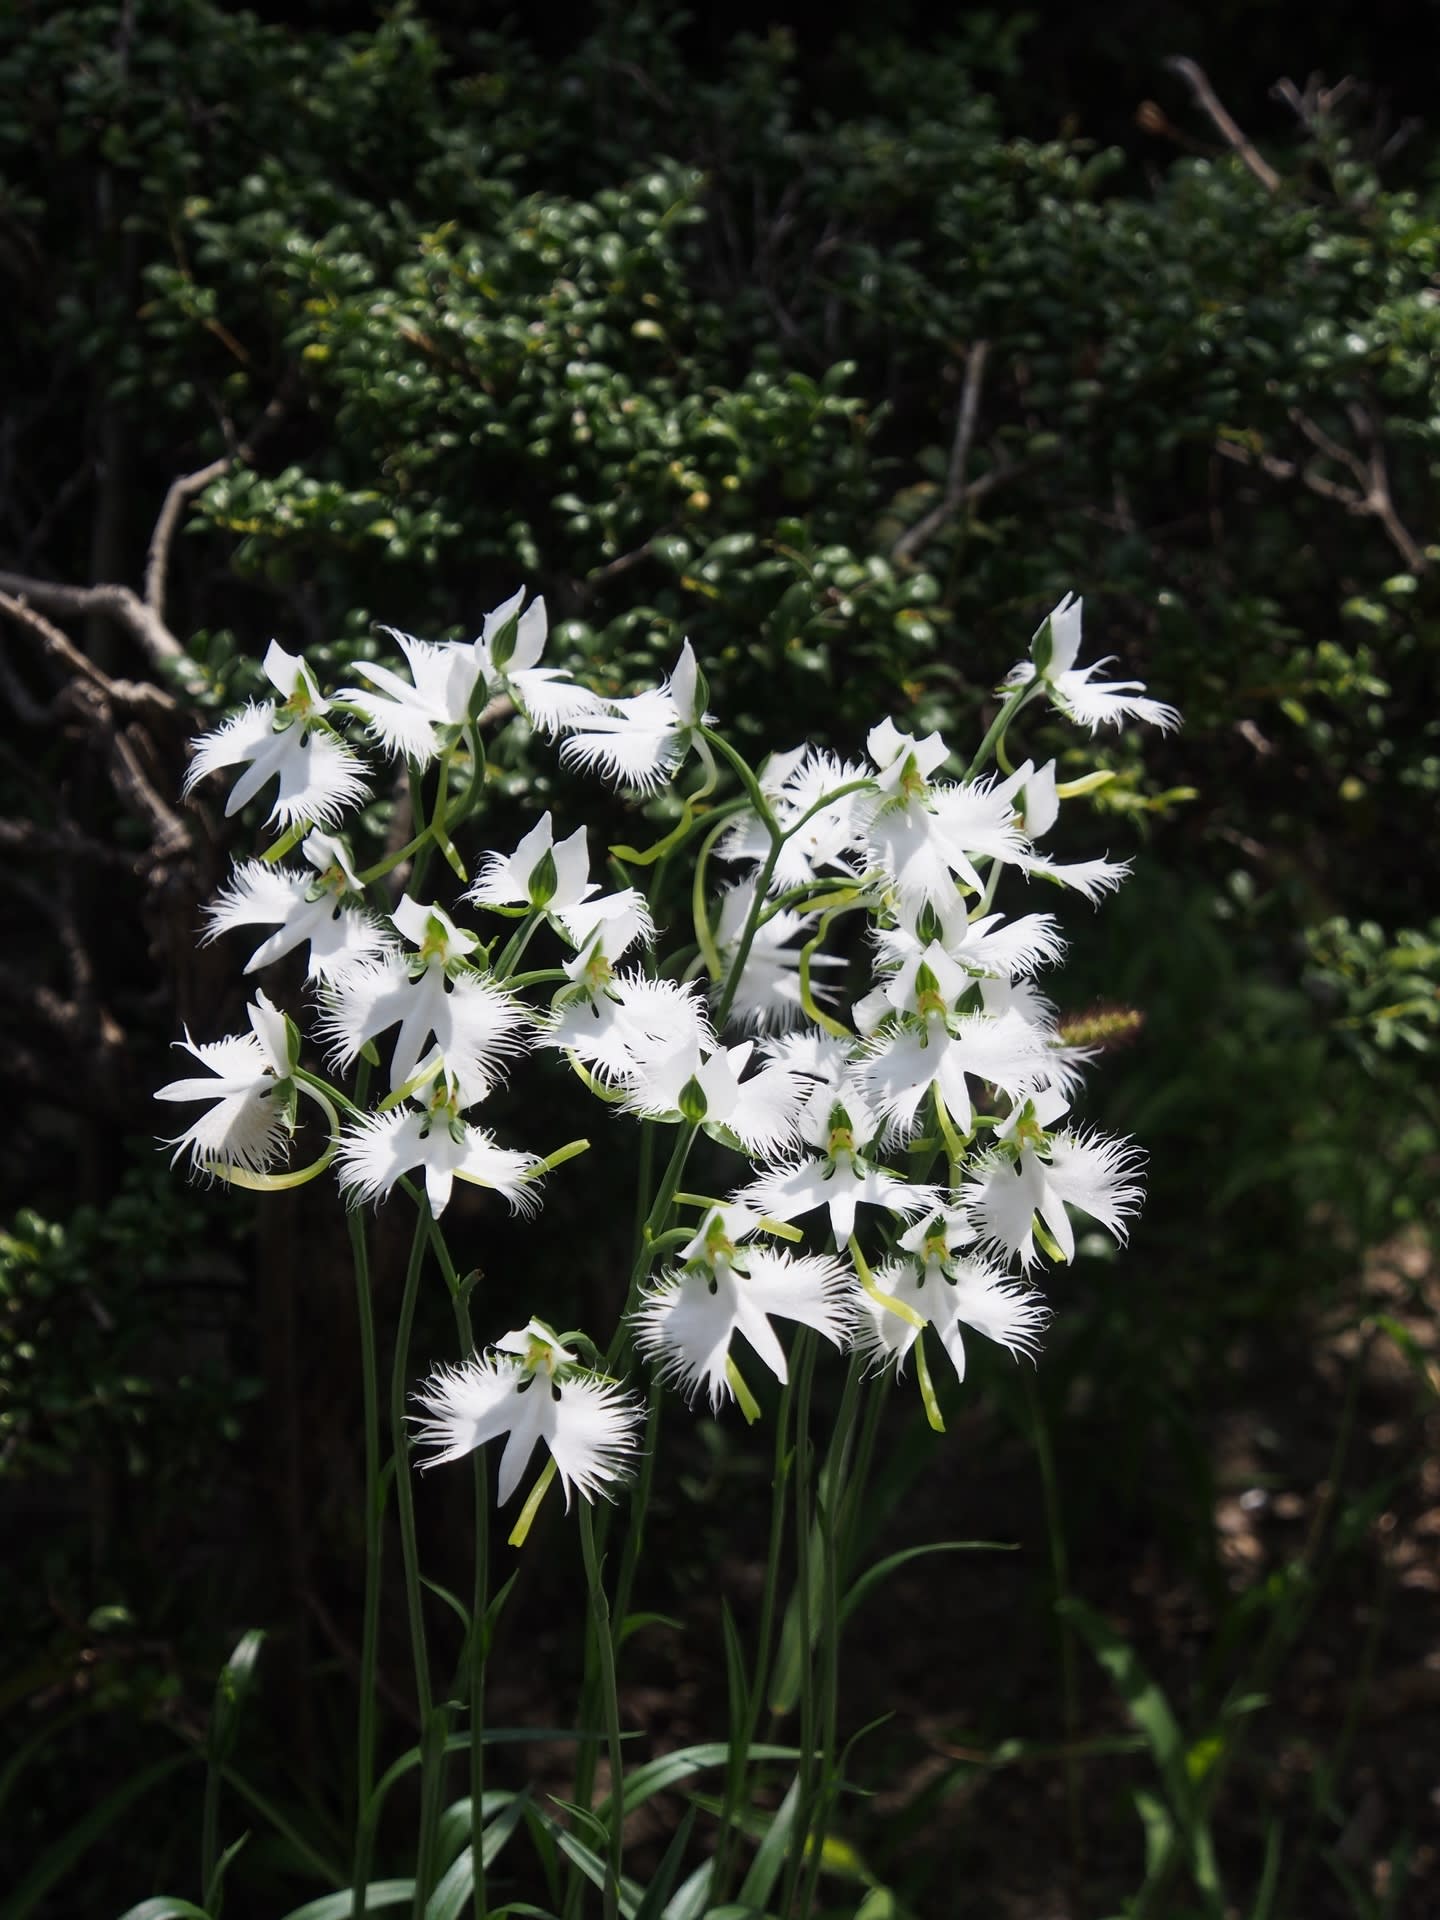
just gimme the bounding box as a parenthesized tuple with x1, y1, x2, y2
(204, 831, 386, 979)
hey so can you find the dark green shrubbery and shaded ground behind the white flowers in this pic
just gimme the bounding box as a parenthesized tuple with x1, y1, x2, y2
(0, 0, 1440, 1920)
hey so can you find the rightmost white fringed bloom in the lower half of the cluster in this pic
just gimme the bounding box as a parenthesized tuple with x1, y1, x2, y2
(960, 1125, 1144, 1271)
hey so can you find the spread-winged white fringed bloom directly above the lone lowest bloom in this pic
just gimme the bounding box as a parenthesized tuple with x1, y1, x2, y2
(338, 1083, 543, 1217)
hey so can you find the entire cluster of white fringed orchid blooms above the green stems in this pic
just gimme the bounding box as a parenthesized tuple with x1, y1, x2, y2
(159, 593, 1175, 1500)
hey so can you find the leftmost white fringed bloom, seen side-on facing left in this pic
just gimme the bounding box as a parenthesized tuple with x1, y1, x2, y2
(156, 993, 294, 1173)
